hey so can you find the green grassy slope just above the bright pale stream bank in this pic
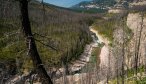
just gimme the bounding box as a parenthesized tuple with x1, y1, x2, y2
(93, 14, 133, 46)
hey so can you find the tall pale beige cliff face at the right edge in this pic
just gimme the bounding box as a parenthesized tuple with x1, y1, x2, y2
(126, 13, 146, 67)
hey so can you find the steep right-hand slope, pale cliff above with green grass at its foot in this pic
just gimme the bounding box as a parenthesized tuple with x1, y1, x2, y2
(110, 11, 146, 84)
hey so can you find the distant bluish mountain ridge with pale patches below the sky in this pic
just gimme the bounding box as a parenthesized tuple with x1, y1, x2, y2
(70, 0, 116, 13)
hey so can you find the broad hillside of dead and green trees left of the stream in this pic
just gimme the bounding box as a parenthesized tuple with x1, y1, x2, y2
(0, 0, 97, 80)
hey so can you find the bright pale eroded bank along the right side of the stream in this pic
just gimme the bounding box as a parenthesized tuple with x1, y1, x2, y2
(90, 27, 116, 84)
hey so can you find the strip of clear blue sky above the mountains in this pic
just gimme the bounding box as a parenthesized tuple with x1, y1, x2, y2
(44, 0, 91, 7)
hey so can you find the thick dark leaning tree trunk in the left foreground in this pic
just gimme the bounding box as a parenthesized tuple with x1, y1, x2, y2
(19, 0, 53, 84)
